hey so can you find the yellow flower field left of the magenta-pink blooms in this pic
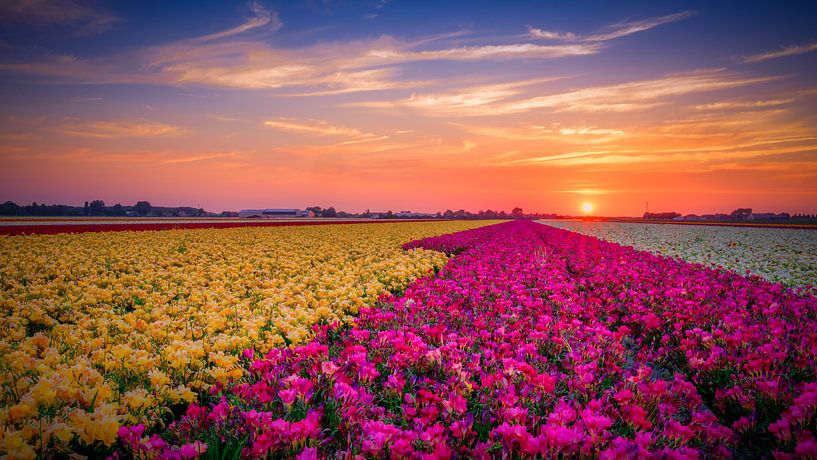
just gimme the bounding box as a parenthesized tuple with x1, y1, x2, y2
(0, 222, 485, 458)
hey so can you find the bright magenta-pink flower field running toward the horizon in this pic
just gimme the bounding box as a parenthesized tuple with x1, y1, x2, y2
(107, 221, 817, 459)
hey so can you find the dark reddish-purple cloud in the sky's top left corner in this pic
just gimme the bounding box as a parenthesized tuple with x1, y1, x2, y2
(0, 0, 119, 35)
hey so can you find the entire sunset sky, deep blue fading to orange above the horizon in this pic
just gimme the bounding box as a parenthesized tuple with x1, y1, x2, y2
(0, 0, 817, 216)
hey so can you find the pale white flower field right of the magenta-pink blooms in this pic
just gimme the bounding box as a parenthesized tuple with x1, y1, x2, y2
(545, 221, 817, 287)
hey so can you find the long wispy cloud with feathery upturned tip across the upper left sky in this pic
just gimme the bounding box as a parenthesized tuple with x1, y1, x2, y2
(0, 18, 604, 91)
